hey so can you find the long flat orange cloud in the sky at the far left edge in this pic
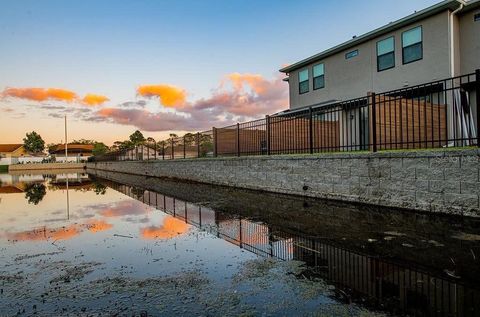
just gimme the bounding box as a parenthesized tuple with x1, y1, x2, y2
(1, 88, 77, 102)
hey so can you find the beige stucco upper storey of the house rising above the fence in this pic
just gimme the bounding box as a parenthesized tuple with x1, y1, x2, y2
(280, 0, 480, 112)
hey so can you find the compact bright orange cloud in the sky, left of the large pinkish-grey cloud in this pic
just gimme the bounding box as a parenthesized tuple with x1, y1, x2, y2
(137, 85, 187, 108)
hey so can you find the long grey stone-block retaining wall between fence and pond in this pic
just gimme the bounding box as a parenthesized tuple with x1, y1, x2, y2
(87, 149, 480, 216)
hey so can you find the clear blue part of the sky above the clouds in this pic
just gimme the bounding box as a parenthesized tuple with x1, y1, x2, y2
(0, 0, 437, 142)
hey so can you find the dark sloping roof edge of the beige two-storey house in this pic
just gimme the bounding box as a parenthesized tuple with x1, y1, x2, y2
(280, 0, 466, 73)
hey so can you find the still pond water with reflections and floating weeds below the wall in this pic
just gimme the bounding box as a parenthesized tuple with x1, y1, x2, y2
(0, 170, 480, 316)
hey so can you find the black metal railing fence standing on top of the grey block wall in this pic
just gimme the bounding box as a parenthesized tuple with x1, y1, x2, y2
(94, 70, 480, 161)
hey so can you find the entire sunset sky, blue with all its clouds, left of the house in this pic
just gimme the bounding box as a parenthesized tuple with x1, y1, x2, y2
(0, 0, 438, 145)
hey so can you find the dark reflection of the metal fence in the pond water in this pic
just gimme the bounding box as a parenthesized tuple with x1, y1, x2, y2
(103, 182, 480, 316)
